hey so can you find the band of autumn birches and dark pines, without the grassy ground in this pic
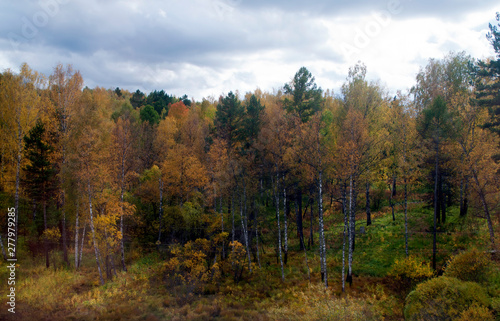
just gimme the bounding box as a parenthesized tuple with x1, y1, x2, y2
(0, 13, 500, 286)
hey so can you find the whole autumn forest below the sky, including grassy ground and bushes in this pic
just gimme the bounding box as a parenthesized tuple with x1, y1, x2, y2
(0, 13, 500, 320)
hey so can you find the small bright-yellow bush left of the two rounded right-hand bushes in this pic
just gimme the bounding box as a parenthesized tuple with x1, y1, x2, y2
(388, 256, 434, 294)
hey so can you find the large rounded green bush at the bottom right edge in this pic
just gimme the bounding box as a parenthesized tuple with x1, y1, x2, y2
(404, 276, 489, 320)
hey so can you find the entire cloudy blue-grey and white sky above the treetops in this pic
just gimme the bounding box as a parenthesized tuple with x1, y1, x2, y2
(0, 0, 500, 101)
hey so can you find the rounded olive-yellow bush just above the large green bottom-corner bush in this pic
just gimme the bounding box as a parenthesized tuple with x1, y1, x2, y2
(444, 249, 492, 283)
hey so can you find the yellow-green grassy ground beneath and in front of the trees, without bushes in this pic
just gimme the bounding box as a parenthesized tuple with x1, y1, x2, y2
(0, 203, 498, 321)
